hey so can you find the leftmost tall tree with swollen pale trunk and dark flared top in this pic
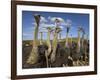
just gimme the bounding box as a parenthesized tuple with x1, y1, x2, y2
(27, 15, 40, 64)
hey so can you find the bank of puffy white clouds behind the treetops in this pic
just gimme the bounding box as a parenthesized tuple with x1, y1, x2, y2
(32, 16, 72, 32)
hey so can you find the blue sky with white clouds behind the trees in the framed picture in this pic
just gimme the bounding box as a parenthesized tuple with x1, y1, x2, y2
(22, 11, 89, 40)
